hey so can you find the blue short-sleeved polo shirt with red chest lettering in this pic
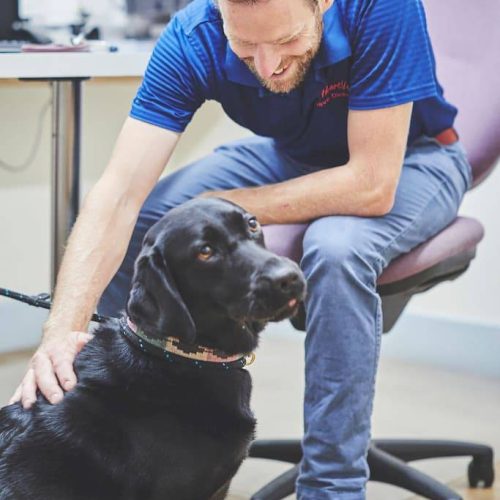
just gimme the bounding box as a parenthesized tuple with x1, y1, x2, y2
(130, 0, 457, 167)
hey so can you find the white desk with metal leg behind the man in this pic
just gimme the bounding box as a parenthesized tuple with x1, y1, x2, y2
(0, 42, 154, 289)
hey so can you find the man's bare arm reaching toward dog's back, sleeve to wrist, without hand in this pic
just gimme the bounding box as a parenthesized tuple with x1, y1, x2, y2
(44, 118, 179, 333)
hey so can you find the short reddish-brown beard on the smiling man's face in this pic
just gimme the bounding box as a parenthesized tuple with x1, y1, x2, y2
(242, 13, 323, 94)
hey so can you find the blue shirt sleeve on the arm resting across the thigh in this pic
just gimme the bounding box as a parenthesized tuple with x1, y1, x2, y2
(346, 0, 438, 109)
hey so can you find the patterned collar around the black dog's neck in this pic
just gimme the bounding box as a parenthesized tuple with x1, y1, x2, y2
(120, 317, 255, 370)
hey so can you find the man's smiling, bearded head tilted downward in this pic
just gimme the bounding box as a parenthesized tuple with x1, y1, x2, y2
(217, 0, 334, 93)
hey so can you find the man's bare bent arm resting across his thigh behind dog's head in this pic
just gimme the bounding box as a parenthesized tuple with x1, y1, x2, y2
(204, 103, 412, 224)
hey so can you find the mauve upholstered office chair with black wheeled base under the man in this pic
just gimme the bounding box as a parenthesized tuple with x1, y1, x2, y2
(250, 0, 500, 500)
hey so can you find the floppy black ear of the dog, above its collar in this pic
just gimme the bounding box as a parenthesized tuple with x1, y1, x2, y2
(127, 245, 196, 343)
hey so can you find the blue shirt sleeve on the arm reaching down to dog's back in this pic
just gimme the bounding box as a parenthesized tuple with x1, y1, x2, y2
(130, 17, 208, 132)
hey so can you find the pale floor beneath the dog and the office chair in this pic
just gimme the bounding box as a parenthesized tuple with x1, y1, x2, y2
(0, 325, 500, 500)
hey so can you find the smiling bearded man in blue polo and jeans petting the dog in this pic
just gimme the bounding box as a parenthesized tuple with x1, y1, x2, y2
(13, 0, 471, 500)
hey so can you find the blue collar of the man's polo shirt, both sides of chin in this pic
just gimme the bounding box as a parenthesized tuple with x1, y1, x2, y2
(224, 2, 351, 88)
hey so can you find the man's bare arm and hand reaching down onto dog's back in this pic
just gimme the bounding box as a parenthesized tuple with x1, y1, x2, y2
(11, 118, 179, 407)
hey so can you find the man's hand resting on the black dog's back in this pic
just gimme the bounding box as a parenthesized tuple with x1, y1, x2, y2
(9, 332, 93, 409)
